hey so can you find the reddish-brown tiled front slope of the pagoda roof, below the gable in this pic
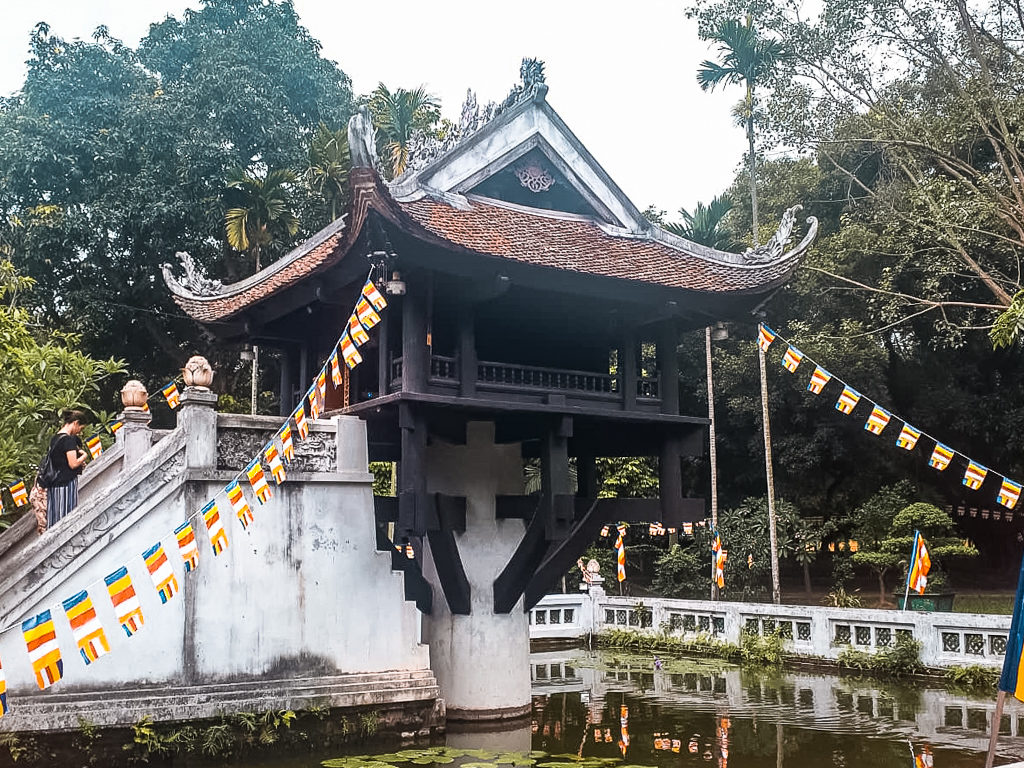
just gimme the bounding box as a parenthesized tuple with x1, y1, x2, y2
(399, 199, 797, 293)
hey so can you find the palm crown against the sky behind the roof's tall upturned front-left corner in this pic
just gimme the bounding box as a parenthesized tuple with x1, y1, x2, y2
(369, 83, 440, 178)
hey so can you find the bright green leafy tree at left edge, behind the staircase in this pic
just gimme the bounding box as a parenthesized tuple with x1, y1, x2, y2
(0, 260, 125, 483)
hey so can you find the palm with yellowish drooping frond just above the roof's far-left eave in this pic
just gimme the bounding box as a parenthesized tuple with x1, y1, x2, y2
(224, 168, 299, 271)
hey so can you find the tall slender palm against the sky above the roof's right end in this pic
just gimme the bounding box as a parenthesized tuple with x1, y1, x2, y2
(697, 16, 787, 246)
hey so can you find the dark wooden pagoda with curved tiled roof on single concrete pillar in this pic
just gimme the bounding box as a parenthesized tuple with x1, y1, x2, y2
(165, 82, 817, 718)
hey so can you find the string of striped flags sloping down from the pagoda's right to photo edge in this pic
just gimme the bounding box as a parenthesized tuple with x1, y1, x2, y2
(758, 323, 1022, 509)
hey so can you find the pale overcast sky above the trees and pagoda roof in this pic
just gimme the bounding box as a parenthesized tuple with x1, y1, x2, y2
(0, 0, 744, 213)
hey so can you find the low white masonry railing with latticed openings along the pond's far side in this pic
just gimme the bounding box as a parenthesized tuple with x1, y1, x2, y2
(529, 590, 1010, 667)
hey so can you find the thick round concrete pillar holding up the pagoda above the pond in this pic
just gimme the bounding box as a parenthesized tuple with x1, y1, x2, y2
(423, 422, 530, 720)
